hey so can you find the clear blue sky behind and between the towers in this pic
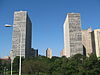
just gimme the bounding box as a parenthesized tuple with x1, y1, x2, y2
(0, 0, 100, 57)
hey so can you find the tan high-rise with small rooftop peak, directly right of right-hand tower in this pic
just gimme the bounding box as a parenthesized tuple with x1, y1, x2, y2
(82, 28, 93, 56)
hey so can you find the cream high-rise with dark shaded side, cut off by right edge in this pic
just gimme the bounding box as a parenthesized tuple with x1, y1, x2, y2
(92, 29, 100, 57)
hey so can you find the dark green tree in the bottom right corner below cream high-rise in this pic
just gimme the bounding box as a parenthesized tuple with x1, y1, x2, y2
(82, 54, 100, 75)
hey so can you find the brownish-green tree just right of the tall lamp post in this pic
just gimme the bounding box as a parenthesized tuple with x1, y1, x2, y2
(22, 56, 49, 75)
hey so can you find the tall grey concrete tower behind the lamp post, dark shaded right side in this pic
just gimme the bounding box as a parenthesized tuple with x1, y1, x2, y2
(11, 11, 32, 59)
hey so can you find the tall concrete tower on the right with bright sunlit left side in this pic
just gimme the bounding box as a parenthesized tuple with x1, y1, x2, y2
(63, 13, 83, 57)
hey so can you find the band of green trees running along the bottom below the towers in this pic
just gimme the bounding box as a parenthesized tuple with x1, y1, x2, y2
(13, 54, 100, 75)
